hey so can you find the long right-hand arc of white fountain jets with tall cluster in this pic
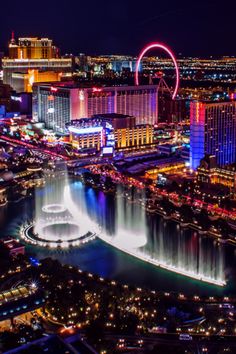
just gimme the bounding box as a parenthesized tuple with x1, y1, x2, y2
(99, 184, 225, 286)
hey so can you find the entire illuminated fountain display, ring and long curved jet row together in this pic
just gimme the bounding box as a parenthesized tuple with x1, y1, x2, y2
(21, 173, 225, 286)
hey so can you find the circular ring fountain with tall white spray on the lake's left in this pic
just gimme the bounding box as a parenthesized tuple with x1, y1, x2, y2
(20, 171, 99, 248)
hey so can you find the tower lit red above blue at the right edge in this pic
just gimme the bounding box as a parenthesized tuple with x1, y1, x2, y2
(190, 101, 236, 169)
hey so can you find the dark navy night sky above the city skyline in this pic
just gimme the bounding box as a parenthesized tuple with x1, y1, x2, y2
(0, 0, 236, 56)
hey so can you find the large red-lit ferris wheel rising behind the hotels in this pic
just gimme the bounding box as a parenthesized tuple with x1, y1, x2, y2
(135, 42, 179, 99)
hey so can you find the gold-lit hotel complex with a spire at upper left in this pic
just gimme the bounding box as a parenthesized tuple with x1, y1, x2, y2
(2, 36, 73, 92)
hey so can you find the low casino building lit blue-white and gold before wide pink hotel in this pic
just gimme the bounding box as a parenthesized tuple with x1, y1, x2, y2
(67, 113, 153, 153)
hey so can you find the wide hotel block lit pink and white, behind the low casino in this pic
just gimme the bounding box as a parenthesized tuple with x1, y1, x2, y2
(33, 82, 158, 131)
